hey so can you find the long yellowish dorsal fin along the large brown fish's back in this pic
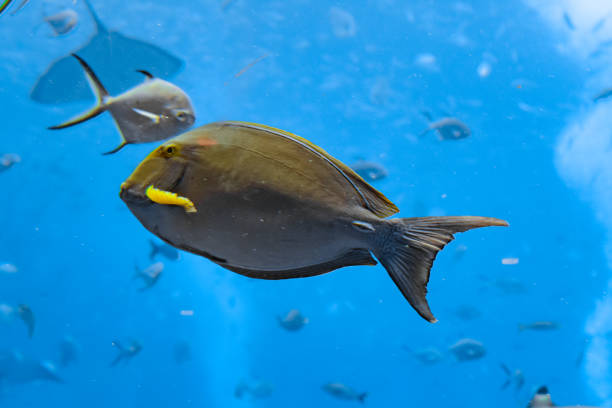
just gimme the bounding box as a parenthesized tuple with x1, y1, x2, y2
(221, 121, 399, 218)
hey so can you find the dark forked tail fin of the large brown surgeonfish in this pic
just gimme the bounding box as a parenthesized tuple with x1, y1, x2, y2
(373, 216, 508, 323)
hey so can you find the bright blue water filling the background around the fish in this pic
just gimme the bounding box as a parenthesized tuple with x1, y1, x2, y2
(0, 0, 612, 408)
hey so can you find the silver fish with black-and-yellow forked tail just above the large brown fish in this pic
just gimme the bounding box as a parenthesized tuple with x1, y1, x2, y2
(49, 54, 195, 154)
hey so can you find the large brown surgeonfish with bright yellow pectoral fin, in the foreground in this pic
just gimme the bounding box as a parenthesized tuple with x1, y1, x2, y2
(121, 122, 506, 321)
